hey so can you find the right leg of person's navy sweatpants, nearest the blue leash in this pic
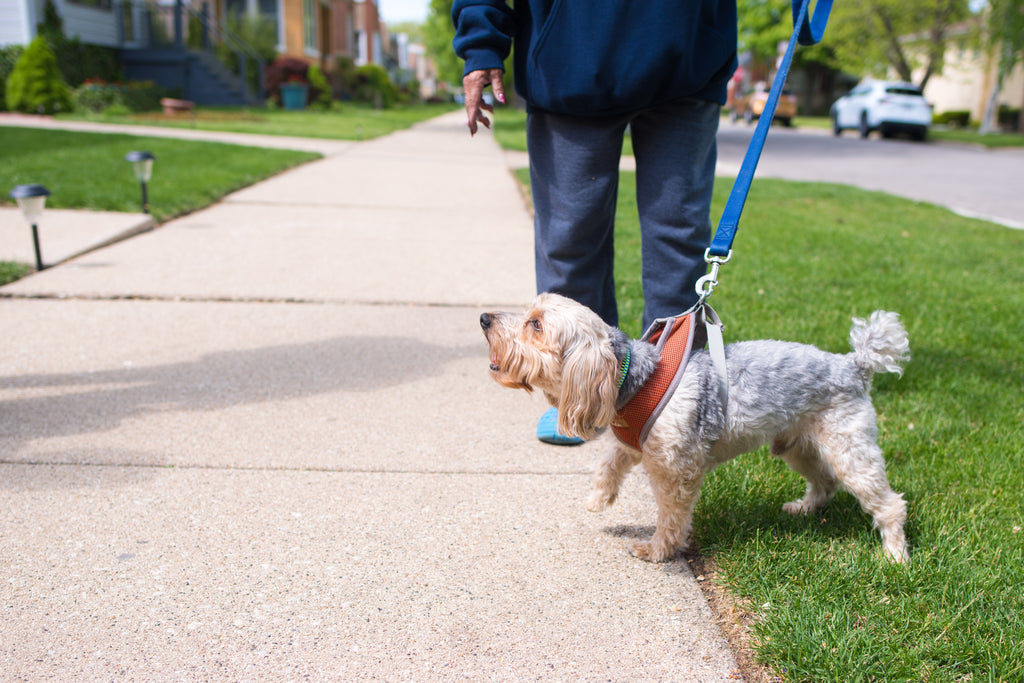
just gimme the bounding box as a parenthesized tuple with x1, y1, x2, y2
(631, 99, 720, 329)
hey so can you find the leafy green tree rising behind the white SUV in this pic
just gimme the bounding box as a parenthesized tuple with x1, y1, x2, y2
(822, 0, 971, 88)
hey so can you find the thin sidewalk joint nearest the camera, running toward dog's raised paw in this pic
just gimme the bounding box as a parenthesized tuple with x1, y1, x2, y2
(0, 459, 592, 477)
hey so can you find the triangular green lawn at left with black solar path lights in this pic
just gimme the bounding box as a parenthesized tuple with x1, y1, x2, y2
(0, 127, 318, 222)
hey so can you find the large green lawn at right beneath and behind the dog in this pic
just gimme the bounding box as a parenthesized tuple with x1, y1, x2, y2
(520, 163, 1024, 682)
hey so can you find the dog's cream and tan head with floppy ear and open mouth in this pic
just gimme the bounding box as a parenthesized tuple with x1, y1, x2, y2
(480, 294, 618, 438)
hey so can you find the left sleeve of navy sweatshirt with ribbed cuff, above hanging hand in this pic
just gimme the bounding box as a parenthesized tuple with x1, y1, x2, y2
(452, 0, 516, 75)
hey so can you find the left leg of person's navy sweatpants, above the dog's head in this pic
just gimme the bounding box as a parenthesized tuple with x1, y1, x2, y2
(526, 112, 626, 326)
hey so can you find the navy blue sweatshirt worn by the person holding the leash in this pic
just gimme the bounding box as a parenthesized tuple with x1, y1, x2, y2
(452, 0, 736, 116)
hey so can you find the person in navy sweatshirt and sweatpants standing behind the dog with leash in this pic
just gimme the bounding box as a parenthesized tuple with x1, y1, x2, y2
(452, 0, 736, 443)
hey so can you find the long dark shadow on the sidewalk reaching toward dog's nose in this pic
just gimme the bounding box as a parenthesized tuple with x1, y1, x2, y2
(0, 336, 486, 458)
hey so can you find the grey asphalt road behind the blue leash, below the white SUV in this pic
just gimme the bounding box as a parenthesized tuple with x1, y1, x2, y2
(718, 120, 1024, 229)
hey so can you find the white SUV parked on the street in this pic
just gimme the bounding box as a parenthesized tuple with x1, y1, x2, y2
(829, 81, 932, 140)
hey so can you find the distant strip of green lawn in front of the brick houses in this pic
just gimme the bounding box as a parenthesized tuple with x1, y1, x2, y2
(59, 103, 458, 140)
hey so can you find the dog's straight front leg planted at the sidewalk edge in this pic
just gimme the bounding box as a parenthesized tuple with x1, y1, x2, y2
(630, 458, 703, 562)
